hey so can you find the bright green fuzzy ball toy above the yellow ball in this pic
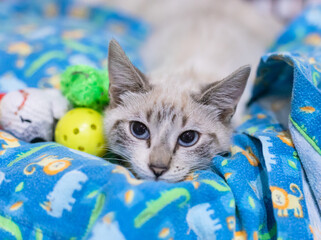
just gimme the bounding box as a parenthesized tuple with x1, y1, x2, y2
(61, 65, 109, 112)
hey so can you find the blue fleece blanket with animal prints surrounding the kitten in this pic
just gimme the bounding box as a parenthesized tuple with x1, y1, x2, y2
(0, 2, 321, 240)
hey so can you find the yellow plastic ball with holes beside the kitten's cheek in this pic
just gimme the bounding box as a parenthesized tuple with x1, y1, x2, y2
(55, 108, 106, 156)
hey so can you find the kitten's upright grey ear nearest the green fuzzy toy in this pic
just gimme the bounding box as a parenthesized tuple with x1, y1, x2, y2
(108, 39, 151, 107)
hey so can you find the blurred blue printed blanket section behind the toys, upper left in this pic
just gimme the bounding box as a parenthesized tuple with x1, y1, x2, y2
(0, 0, 148, 92)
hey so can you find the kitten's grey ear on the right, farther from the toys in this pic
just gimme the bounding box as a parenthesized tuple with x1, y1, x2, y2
(192, 65, 251, 122)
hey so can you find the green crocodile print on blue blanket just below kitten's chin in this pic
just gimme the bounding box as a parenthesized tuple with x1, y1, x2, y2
(134, 188, 191, 228)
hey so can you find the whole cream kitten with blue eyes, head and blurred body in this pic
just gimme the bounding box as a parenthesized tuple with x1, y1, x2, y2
(102, 0, 280, 182)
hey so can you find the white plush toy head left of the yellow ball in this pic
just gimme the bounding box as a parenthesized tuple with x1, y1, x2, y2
(0, 88, 69, 143)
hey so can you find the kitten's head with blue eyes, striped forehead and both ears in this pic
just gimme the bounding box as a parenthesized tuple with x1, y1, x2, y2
(104, 40, 250, 182)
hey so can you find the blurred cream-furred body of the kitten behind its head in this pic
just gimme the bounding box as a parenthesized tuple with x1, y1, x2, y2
(82, 0, 282, 125)
